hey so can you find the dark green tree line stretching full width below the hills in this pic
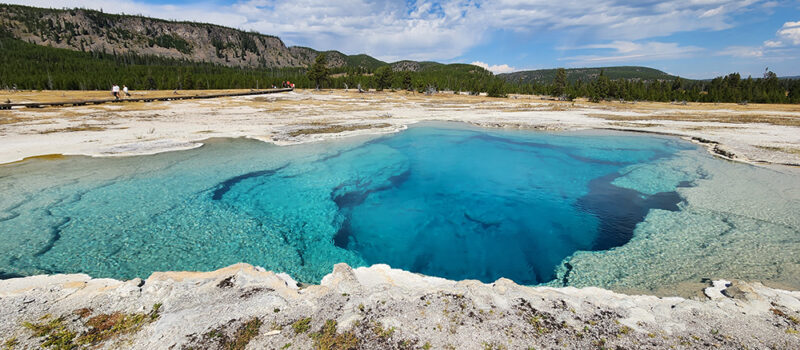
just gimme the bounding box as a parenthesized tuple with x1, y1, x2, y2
(0, 34, 800, 103)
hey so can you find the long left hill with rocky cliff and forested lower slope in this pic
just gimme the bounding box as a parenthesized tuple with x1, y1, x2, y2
(0, 4, 502, 94)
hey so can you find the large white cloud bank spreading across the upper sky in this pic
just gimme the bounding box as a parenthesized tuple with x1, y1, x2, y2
(0, 0, 768, 61)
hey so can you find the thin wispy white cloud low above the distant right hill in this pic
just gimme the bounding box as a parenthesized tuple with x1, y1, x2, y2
(561, 41, 703, 64)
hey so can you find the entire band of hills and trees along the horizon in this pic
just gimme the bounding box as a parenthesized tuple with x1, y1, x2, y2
(0, 4, 800, 103)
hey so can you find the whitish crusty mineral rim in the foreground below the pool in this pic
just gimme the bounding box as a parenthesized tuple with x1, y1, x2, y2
(0, 264, 800, 349)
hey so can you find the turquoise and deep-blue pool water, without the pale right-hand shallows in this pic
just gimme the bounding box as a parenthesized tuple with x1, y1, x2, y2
(0, 124, 703, 284)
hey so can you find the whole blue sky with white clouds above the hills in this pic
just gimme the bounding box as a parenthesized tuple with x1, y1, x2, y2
(9, 0, 800, 78)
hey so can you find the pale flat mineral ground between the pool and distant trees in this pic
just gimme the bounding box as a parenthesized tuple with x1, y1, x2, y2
(0, 91, 800, 167)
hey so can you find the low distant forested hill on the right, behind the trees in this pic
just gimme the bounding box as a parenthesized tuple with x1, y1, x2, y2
(498, 66, 678, 84)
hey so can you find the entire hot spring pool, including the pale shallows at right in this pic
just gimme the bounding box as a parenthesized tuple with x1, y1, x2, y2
(0, 124, 800, 289)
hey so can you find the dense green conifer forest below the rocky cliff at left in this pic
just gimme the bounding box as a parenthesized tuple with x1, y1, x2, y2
(0, 33, 307, 90)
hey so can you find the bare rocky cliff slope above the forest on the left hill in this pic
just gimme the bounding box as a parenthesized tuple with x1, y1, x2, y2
(0, 4, 386, 70)
